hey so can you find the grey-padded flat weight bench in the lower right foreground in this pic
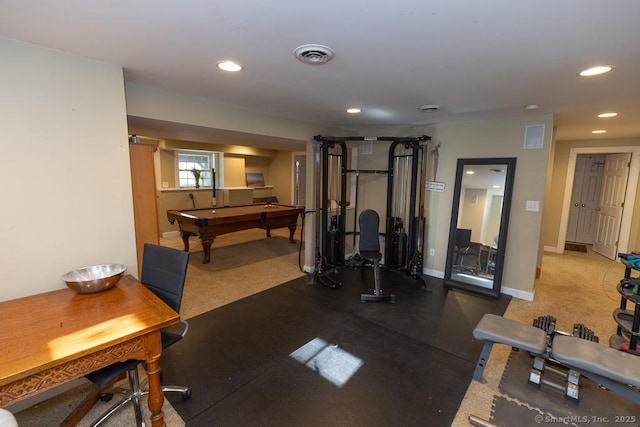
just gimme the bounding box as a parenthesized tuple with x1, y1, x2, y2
(473, 314, 640, 404)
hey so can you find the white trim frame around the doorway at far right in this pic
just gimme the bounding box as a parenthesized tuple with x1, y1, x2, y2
(556, 145, 640, 253)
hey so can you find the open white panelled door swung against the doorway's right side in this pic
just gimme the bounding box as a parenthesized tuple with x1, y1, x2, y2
(593, 153, 631, 259)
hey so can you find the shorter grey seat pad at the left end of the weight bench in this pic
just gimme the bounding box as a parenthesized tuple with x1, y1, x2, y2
(473, 313, 544, 354)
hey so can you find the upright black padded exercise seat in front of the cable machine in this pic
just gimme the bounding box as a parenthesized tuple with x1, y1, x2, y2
(358, 209, 396, 302)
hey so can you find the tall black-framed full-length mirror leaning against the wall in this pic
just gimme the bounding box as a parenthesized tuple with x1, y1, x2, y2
(444, 158, 516, 297)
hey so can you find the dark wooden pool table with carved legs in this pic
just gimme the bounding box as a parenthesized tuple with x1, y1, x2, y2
(167, 203, 304, 264)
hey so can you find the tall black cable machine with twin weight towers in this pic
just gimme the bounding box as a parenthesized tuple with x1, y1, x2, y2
(313, 135, 431, 288)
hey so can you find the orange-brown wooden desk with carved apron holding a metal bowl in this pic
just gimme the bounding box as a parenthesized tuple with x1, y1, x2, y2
(0, 276, 180, 426)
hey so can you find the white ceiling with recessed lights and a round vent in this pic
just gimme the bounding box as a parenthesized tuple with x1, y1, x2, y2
(0, 0, 640, 147)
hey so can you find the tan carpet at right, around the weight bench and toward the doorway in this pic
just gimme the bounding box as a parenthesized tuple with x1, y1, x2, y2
(453, 247, 624, 426)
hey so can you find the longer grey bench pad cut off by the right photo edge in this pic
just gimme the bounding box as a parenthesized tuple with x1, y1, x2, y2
(551, 335, 640, 387)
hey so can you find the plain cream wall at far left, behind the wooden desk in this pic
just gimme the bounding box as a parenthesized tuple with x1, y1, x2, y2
(0, 38, 137, 300)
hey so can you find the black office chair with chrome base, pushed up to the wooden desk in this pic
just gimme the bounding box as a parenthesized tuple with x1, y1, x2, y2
(62, 243, 191, 426)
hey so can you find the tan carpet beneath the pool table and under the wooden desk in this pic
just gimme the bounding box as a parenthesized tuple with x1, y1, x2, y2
(11, 227, 305, 427)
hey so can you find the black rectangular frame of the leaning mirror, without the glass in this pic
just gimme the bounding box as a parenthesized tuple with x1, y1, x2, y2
(444, 157, 516, 298)
